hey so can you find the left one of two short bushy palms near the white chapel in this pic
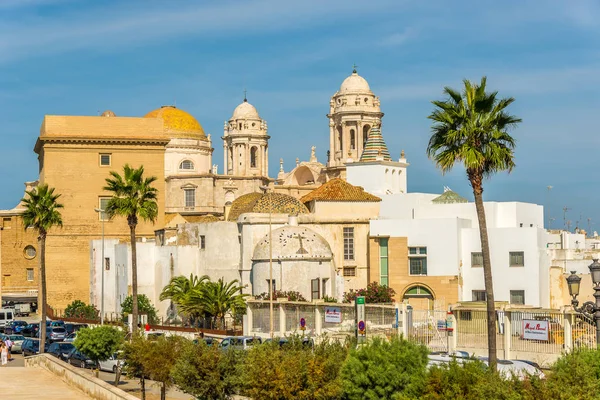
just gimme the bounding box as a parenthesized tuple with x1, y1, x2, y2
(160, 274, 210, 324)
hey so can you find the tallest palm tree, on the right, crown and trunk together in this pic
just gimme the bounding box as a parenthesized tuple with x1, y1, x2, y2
(427, 77, 521, 370)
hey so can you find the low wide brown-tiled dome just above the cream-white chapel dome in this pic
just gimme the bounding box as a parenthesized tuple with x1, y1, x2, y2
(227, 193, 308, 222)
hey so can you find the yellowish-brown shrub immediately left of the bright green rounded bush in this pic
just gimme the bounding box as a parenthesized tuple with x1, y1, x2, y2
(243, 336, 347, 400)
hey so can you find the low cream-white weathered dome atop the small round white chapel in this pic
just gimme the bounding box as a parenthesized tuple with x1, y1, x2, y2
(252, 225, 333, 261)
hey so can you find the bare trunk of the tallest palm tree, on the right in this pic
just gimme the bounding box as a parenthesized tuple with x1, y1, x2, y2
(472, 187, 498, 371)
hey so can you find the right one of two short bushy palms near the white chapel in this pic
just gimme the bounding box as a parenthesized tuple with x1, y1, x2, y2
(197, 278, 248, 327)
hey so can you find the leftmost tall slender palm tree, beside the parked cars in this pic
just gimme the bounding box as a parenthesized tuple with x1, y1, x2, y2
(21, 185, 63, 353)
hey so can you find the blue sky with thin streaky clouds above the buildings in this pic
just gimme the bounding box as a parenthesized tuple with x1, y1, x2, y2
(0, 0, 600, 230)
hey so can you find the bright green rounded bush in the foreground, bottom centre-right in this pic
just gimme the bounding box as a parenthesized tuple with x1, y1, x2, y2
(341, 337, 428, 400)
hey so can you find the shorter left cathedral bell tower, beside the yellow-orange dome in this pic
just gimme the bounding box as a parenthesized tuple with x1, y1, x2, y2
(222, 95, 270, 177)
